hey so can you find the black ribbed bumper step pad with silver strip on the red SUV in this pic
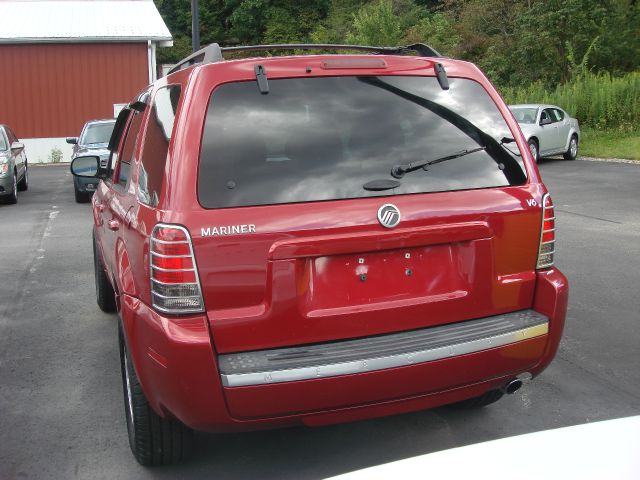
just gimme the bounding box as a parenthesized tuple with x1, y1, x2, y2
(218, 310, 549, 387)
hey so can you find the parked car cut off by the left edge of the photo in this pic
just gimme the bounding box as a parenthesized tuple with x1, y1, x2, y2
(0, 125, 29, 203)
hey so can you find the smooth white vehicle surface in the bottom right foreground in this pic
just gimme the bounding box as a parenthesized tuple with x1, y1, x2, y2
(326, 416, 640, 480)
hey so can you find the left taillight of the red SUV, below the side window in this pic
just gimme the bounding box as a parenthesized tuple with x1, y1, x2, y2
(150, 224, 204, 314)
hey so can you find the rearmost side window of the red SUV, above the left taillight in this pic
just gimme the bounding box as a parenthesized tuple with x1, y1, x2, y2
(138, 85, 181, 207)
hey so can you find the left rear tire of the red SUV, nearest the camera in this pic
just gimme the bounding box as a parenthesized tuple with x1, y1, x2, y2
(118, 326, 192, 466)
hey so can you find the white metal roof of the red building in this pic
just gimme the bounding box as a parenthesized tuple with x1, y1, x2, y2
(0, 0, 171, 46)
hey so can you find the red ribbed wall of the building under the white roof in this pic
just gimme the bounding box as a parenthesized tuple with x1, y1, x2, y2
(0, 42, 149, 138)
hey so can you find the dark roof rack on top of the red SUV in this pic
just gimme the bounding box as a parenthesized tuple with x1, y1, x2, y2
(168, 43, 440, 73)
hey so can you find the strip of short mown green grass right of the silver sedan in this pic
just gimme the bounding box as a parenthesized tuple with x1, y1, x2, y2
(580, 129, 640, 160)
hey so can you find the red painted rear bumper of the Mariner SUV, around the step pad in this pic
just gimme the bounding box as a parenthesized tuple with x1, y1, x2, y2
(121, 269, 568, 431)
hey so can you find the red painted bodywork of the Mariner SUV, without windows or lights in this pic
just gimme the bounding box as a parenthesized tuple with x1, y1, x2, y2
(95, 56, 568, 431)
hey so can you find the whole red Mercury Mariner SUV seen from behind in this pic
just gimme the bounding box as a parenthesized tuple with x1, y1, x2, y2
(71, 44, 568, 465)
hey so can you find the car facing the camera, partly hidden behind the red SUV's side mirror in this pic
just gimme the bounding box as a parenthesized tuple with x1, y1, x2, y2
(67, 119, 116, 203)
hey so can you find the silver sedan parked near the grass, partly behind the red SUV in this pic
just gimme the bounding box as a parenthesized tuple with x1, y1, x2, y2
(509, 105, 580, 162)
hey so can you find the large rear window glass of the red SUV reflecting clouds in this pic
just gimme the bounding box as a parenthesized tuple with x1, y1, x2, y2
(198, 76, 526, 208)
